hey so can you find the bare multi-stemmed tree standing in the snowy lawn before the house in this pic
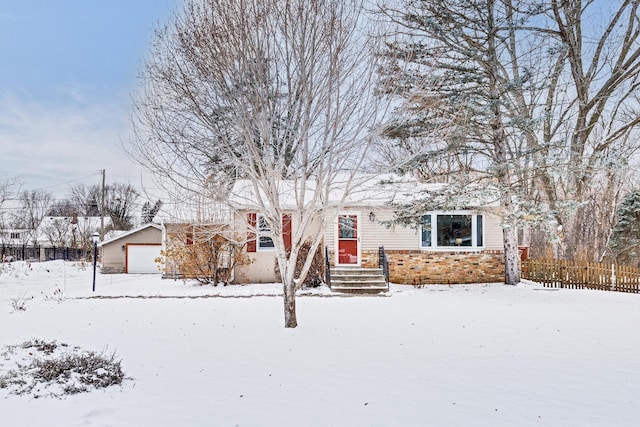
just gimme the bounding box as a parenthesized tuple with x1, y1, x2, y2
(132, 0, 378, 327)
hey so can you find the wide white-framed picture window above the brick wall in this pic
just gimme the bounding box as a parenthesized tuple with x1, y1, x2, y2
(420, 212, 484, 248)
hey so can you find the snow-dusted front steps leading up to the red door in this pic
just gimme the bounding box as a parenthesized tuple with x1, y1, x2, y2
(331, 267, 389, 294)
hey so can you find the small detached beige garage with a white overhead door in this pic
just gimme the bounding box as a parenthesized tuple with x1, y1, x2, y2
(100, 223, 162, 274)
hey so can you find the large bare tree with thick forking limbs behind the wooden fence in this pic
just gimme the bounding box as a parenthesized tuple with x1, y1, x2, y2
(540, 0, 640, 260)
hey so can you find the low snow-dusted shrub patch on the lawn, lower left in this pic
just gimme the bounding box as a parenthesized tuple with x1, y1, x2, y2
(0, 339, 125, 398)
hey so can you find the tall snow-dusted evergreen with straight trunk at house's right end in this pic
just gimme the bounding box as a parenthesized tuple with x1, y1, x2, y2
(381, 0, 552, 284)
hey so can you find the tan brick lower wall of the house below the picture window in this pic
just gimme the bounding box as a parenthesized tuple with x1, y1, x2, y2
(362, 250, 504, 284)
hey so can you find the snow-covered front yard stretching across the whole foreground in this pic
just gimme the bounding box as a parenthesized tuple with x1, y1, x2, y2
(0, 261, 640, 426)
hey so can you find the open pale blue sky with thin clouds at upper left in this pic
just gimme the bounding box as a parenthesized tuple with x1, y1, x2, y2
(0, 0, 179, 198)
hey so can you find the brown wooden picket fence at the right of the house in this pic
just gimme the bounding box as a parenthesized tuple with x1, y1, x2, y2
(522, 259, 640, 293)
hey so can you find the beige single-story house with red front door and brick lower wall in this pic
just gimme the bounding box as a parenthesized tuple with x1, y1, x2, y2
(234, 177, 504, 284)
